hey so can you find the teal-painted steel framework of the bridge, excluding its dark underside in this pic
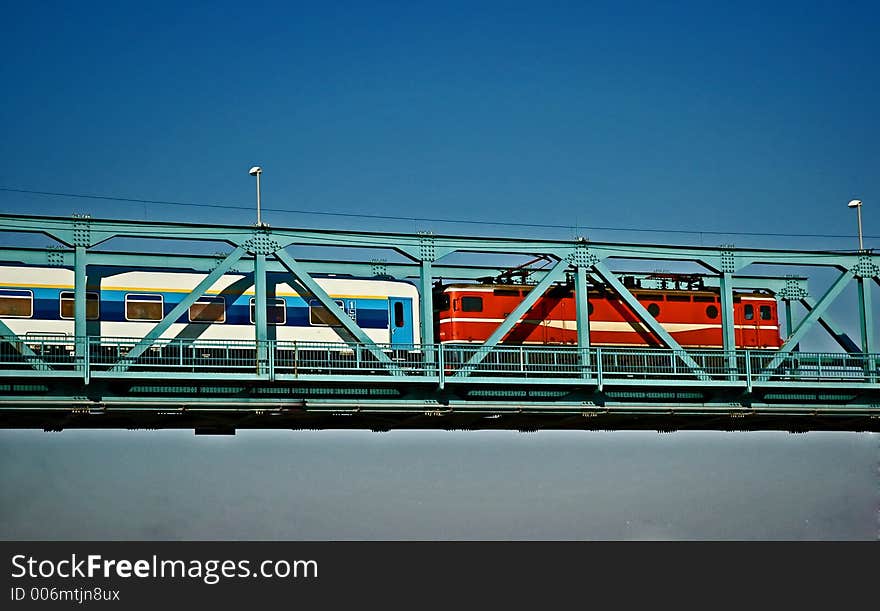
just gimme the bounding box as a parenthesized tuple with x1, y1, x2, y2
(0, 215, 880, 422)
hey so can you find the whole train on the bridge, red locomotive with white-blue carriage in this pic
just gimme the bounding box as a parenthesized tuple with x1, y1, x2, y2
(0, 266, 783, 350)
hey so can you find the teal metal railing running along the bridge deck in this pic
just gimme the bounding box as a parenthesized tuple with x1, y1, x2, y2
(0, 335, 880, 386)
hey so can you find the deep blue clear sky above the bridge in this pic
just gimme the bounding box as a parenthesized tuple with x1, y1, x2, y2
(0, 2, 880, 248)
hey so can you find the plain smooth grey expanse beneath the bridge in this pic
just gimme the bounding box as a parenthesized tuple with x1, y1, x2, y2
(0, 431, 880, 540)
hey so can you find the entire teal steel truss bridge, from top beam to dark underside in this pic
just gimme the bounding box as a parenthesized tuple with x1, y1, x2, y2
(0, 215, 880, 433)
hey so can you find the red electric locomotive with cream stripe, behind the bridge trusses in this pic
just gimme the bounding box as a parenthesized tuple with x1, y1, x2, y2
(435, 284, 782, 348)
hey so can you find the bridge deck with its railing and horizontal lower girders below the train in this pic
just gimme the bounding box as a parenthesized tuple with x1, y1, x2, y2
(0, 337, 880, 430)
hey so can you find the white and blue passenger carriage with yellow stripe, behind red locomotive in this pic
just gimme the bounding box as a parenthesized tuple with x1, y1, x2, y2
(0, 267, 420, 347)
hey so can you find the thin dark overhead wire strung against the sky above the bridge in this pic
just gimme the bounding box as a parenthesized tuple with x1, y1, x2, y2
(0, 186, 880, 239)
